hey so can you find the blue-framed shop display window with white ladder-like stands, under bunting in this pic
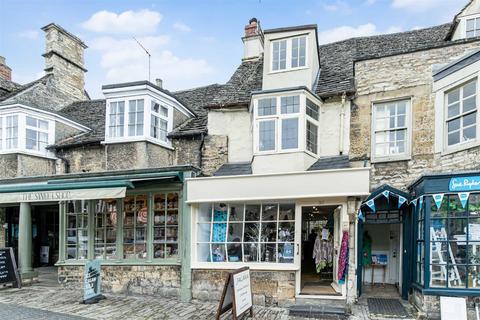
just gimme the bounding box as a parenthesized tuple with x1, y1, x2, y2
(416, 194, 480, 290)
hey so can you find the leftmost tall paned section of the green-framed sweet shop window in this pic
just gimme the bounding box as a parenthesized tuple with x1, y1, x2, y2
(65, 200, 89, 260)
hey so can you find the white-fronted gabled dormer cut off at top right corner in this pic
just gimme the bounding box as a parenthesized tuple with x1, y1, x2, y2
(448, 0, 480, 40)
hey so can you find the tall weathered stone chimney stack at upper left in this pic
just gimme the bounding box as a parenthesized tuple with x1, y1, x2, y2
(42, 23, 88, 100)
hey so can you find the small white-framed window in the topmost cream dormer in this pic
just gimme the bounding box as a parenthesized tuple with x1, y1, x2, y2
(272, 36, 307, 71)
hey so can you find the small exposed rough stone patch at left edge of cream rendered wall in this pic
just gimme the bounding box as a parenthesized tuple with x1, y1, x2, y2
(202, 135, 228, 176)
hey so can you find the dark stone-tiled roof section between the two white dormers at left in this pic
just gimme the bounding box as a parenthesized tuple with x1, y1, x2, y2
(51, 99, 106, 148)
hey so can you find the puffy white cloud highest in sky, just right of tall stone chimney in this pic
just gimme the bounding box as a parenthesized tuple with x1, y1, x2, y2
(82, 9, 162, 34)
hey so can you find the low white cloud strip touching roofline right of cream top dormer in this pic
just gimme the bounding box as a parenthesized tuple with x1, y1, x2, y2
(318, 23, 402, 44)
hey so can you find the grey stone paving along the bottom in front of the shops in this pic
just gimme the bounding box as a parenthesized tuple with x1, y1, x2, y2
(0, 286, 414, 320)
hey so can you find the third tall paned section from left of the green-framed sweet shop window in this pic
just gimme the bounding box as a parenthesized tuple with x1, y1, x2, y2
(123, 195, 148, 259)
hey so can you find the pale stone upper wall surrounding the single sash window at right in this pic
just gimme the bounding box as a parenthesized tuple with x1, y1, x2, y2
(350, 41, 480, 189)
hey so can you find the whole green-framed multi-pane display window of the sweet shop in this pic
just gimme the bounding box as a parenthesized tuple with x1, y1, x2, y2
(65, 192, 179, 262)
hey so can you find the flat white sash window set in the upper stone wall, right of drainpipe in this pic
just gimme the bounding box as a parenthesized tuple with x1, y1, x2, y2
(372, 100, 410, 160)
